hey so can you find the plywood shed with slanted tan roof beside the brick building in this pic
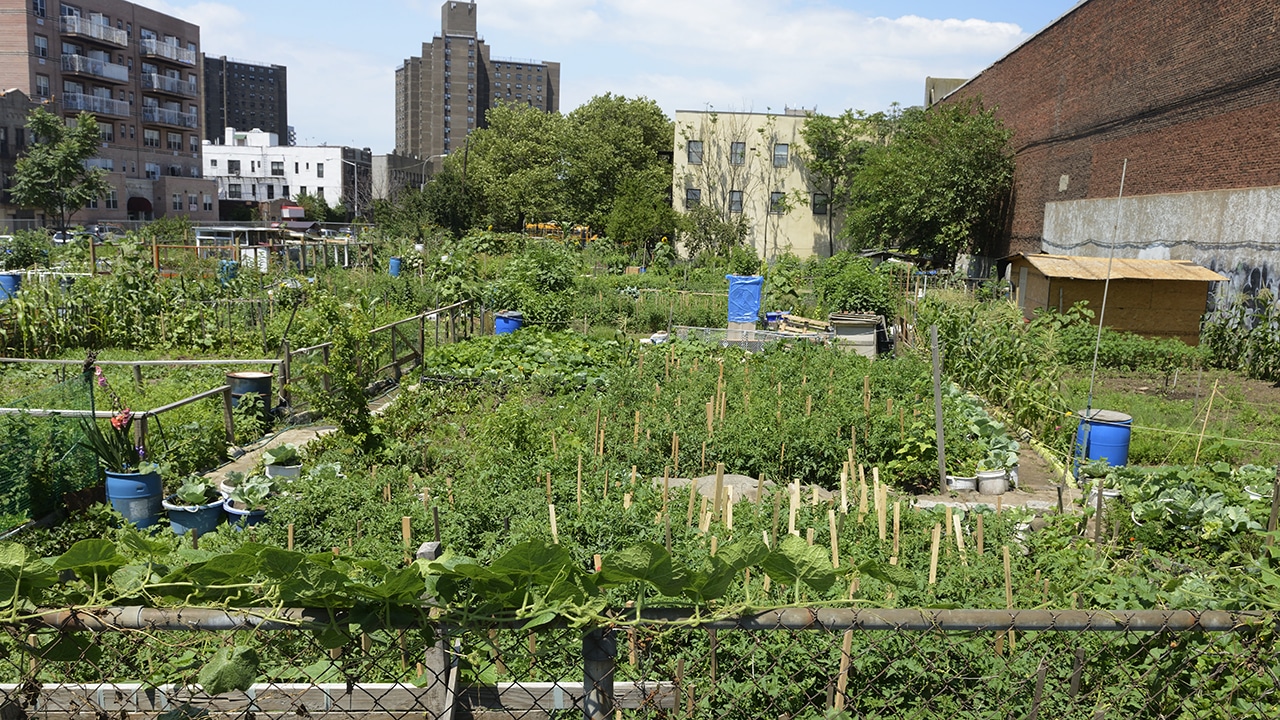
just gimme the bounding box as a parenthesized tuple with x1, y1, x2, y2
(1005, 254, 1226, 345)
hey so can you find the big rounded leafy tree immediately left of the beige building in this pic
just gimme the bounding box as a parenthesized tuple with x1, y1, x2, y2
(563, 94, 675, 236)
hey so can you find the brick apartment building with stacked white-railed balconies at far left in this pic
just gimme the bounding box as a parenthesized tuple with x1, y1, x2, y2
(0, 0, 218, 224)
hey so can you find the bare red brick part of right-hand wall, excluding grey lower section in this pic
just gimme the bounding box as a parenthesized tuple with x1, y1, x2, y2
(947, 0, 1280, 252)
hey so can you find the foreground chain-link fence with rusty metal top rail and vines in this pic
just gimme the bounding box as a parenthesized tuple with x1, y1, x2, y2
(0, 609, 1280, 720)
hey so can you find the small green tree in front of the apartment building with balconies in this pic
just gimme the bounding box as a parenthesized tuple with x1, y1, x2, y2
(10, 108, 111, 229)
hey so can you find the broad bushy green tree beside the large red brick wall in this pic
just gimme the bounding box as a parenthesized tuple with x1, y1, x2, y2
(845, 101, 1014, 266)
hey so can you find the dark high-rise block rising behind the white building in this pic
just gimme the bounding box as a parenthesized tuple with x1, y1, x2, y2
(205, 55, 293, 145)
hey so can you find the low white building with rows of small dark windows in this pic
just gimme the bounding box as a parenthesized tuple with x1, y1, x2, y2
(204, 128, 372, 214)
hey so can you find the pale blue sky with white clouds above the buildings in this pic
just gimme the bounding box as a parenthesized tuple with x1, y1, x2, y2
(134, 0, 1075, 154)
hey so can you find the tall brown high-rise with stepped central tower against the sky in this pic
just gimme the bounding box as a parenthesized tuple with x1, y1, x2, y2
(396, 1, 559, 161)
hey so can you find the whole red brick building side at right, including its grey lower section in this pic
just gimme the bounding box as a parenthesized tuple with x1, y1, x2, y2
(947, 0, 1280, 292)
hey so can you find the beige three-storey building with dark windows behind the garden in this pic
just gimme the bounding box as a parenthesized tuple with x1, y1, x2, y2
(672, 110, 840, 258)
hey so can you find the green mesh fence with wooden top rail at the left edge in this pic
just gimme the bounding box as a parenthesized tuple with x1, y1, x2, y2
(0, 373, 100, 520)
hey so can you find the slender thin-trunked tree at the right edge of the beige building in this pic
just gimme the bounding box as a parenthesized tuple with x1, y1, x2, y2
(800, 110, 872, 256)
